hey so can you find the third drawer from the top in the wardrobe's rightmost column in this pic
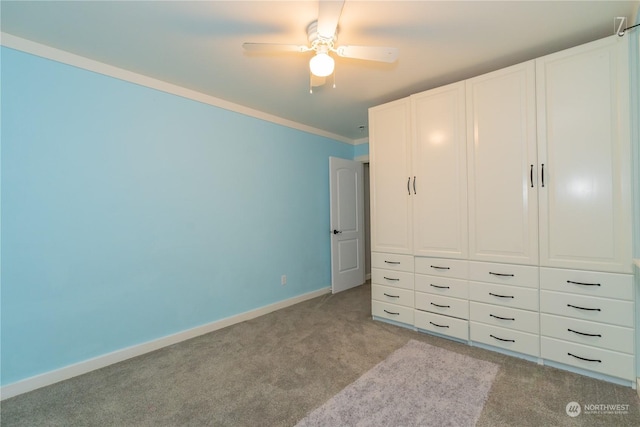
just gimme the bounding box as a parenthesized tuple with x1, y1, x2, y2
(540, 314, 634, 354)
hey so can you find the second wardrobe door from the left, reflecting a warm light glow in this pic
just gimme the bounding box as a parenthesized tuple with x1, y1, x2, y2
(411, 82, 468, 258)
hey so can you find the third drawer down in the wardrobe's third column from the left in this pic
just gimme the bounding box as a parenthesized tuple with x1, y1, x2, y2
(469, 301, 540, 334)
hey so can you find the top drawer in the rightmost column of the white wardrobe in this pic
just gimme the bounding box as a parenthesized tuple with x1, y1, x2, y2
(540, 267, 633, 301)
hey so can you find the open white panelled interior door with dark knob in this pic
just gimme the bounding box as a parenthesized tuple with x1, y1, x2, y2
(329, 157, 364, 294)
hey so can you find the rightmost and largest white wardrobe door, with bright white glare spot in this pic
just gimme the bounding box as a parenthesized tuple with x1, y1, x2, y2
(536, 36, 632, 273)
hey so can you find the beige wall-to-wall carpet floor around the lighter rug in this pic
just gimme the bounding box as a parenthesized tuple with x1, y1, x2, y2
(0, 284, 640, 427)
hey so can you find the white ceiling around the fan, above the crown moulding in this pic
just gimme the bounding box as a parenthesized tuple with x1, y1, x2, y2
(1, 0, 640, 141)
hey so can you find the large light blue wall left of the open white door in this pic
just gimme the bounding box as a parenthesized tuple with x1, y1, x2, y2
(1, 48, 354, 385)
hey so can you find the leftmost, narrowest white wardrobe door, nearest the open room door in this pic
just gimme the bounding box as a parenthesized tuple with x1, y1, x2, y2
(369, 98, 413, 254)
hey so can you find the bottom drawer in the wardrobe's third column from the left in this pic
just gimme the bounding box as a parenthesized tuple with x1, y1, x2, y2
(469, 322, 540, 356)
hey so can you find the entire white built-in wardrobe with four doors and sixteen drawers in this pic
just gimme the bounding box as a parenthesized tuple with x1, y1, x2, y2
(369, 36, 636, 385)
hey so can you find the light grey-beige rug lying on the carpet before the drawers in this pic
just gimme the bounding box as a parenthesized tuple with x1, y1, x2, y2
(298, 340, 499, 427)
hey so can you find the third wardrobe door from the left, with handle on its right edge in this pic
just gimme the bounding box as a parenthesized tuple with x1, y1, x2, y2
(467, 61, 539, 265)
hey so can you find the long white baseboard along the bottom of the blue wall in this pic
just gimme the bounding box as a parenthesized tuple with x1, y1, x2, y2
(0, 287, 331, 400)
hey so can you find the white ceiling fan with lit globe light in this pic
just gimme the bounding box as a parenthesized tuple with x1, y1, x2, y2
(242, 0, 398, 92)
